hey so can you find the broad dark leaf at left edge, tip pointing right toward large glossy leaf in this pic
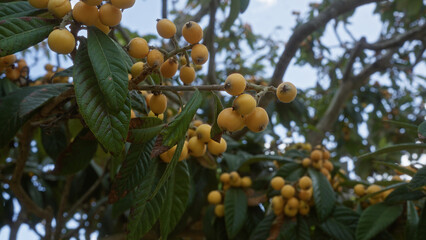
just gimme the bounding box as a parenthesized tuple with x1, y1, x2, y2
(0, 84, 69, 148)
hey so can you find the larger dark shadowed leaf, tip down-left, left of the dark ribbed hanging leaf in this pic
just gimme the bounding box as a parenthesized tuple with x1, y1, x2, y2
(54, 128, 98, 175)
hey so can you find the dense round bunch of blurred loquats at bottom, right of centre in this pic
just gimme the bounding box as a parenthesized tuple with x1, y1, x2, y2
(271, 176, 314, 217)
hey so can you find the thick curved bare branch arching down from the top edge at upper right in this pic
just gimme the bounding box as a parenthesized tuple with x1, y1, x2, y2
(260, 0, 383, 107)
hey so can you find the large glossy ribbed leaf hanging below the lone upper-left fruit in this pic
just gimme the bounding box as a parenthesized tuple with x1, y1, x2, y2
(74, 37, 130, 154)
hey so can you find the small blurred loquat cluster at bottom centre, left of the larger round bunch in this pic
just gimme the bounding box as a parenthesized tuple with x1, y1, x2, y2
(207, 171, 252, 217)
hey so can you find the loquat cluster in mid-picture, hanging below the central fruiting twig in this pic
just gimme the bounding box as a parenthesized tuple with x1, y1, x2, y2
(160, 120, 227, 163)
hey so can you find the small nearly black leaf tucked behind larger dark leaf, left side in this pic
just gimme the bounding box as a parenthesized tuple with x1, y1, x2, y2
(41, 123, 68, 160)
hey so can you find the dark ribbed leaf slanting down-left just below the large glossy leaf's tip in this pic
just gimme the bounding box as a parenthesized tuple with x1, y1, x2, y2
(109, 140, 156, 203)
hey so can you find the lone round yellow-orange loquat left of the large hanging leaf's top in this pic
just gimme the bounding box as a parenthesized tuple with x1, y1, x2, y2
(47, 29, 75, 54)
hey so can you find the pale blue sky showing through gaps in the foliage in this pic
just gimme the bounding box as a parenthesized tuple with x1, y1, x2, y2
(0, 0, 426, 240)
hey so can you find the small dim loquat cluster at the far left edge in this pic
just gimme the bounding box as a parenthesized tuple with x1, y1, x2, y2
(0, 54, 29, 84)
